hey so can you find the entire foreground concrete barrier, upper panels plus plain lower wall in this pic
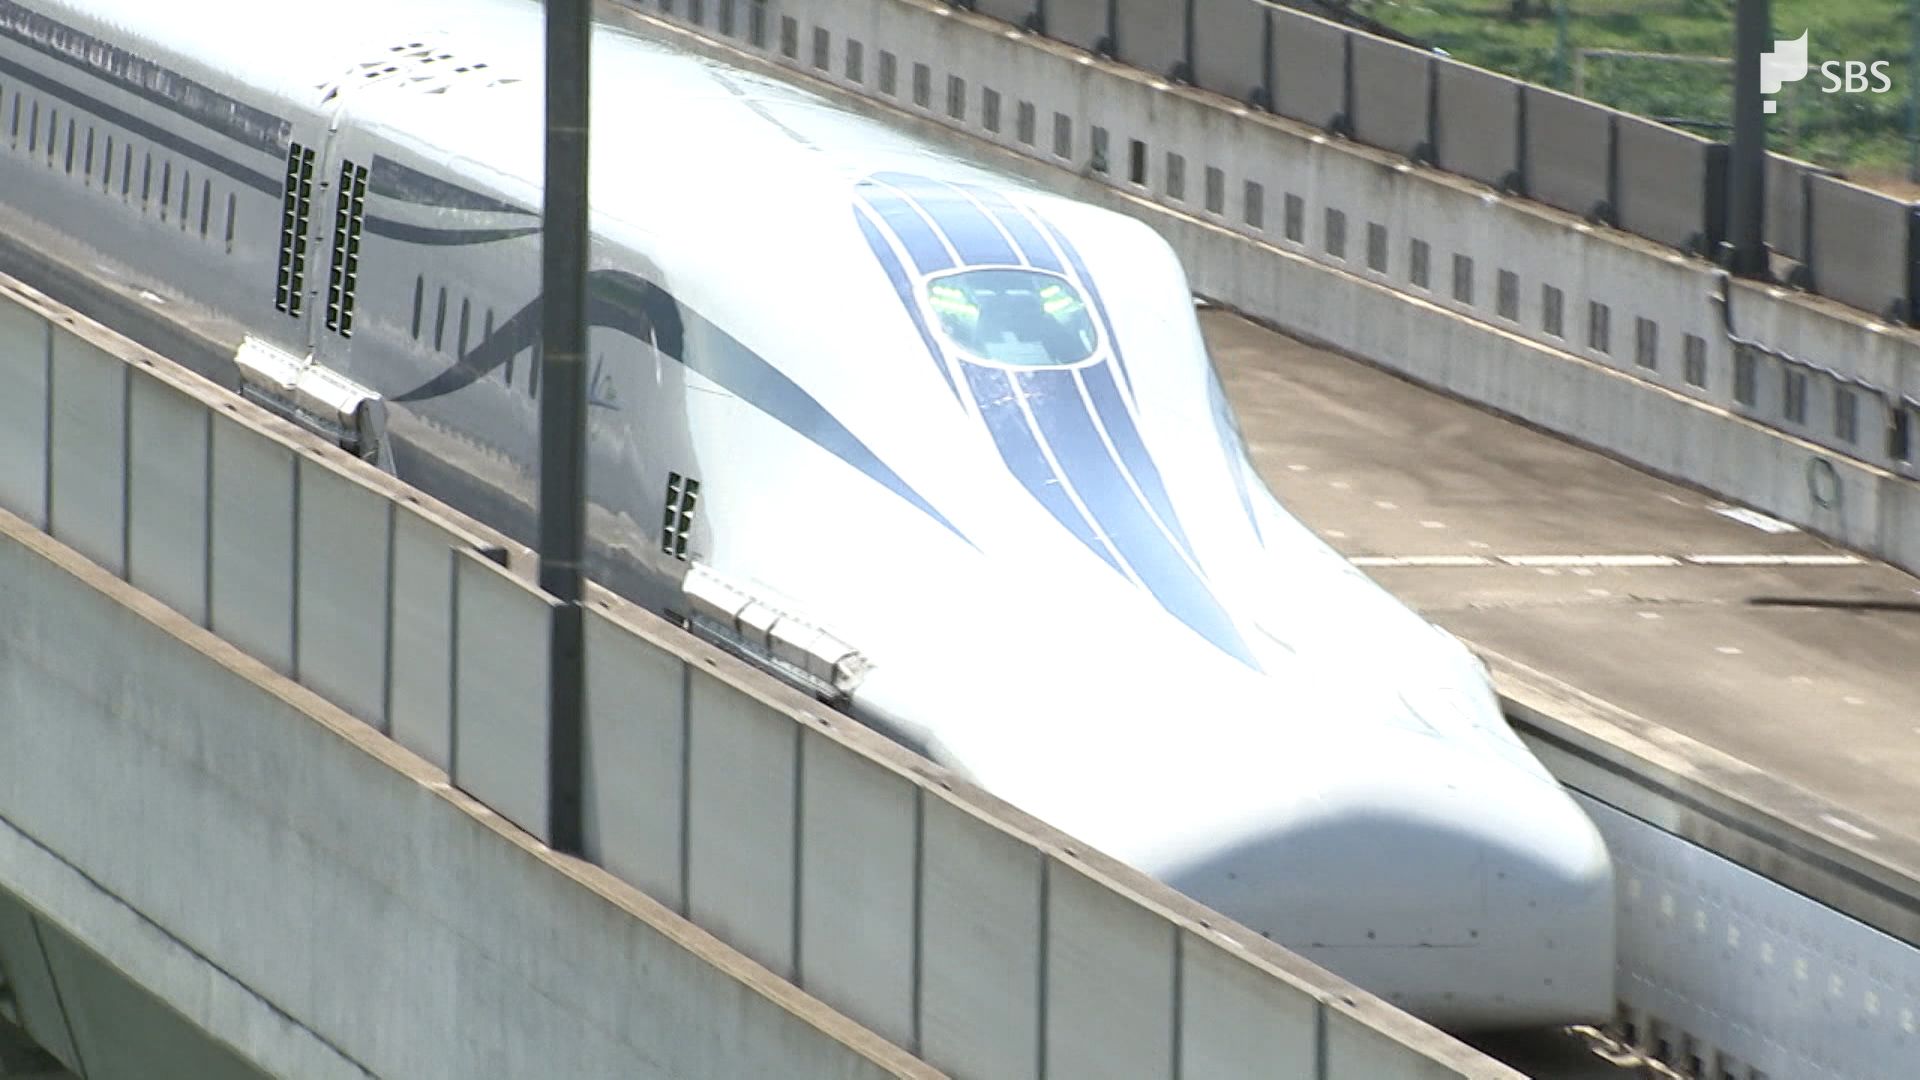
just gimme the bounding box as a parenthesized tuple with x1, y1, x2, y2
(0, 274, 1513, 1080)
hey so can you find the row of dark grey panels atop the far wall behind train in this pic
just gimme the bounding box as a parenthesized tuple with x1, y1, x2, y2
(998, 0, 1920, 323)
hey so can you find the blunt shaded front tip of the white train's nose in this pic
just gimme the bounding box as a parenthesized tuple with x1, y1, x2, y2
(1152, 746, 1615, 1030)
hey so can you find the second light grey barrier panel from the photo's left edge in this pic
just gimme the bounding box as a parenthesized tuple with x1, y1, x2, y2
(48, 327, 127, 575)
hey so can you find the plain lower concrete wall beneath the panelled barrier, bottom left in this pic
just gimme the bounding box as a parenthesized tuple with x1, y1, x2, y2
(0, 521, 931, 1080)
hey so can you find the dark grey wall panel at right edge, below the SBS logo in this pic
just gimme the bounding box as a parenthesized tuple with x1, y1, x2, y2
(1804, 177, 1912, 319)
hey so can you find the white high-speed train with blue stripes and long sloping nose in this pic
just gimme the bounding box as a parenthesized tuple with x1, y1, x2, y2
(0, 0, 1615, 1028)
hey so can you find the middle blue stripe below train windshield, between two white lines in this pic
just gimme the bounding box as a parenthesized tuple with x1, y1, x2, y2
(1018, 371, 1260, 669)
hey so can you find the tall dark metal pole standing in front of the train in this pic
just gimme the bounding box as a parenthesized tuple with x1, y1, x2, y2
(540, 0, 593, 855)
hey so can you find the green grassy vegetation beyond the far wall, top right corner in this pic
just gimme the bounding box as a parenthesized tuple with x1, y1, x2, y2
(1354, 0, 1920, 183)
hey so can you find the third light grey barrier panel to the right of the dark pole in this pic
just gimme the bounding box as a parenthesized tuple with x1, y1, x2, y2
(801, 732, 920, 1045)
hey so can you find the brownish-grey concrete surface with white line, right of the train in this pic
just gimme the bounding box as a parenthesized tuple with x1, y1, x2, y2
(1204, 303, 1920, 857)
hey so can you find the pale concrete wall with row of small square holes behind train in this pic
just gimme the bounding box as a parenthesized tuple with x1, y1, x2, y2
(634, 0, 1920, 569)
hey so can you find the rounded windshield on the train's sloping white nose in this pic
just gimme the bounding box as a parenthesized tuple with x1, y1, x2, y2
(927, 269, 1098, 367)
